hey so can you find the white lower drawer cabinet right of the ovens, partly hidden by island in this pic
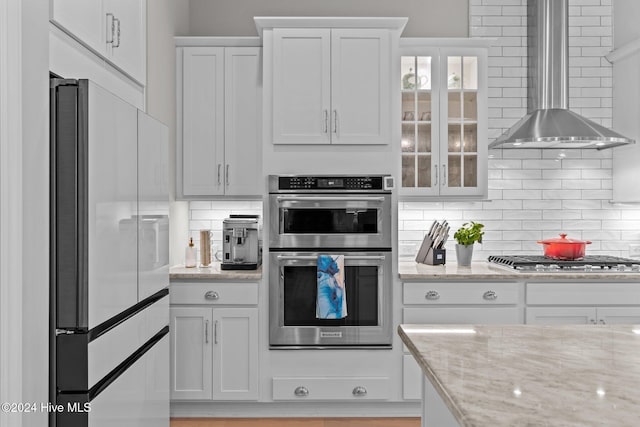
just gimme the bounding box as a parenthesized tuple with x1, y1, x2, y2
(402, 282, 524, 402)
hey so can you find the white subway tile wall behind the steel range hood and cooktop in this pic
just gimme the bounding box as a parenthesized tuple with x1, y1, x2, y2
(399, 0, 640, 260)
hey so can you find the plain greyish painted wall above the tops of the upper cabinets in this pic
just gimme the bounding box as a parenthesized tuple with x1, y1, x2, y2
(190, 0, 469, 37)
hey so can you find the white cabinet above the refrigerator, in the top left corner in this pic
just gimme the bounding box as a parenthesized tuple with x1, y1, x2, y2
(51, 0, 147, 85)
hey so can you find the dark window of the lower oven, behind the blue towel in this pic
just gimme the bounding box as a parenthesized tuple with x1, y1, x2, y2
(283, 266, 378, 326)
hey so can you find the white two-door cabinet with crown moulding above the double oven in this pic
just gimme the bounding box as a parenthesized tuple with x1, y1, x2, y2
(256, 18, 406, 145)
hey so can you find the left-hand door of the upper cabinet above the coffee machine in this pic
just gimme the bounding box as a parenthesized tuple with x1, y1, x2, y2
(182, 47, 224, 196)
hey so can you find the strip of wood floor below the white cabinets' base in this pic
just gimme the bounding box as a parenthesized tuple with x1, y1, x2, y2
(171, 418, 420, 427)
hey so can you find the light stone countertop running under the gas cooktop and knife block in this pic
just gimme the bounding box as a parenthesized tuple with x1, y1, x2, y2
(398, 260, 640, 281)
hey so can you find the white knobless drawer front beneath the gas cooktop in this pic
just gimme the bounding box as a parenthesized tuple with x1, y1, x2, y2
(526, 283, 640, 306)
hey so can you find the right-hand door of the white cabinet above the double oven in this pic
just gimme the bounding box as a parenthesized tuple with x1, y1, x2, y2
(331, 29, 391, 144)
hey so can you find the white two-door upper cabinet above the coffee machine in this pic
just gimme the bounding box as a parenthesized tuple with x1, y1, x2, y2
(177, 41, 264, 198)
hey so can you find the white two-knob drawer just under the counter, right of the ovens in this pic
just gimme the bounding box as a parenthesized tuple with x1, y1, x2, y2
(403, 282, 520, 305)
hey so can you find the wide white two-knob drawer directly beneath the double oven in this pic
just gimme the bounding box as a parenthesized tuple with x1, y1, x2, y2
(273, 377, 391, 401)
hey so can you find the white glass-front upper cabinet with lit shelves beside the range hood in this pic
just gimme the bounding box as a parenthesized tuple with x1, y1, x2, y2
(400, 39, 488, 198)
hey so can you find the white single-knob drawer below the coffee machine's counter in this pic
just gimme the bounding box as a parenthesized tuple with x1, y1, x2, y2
(170, 283, 258, 305)
